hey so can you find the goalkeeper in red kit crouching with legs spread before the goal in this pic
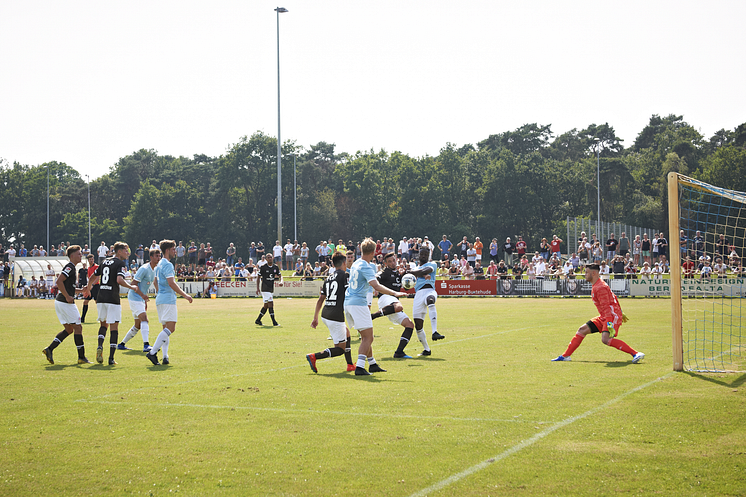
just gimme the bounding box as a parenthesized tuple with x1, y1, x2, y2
(552, 264, 645, 363)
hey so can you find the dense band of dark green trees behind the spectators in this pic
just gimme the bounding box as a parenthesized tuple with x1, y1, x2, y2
(0, 115, 746, 255)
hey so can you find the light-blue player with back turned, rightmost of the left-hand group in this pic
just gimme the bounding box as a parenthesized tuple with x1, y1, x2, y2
(145, 240, 192, 366)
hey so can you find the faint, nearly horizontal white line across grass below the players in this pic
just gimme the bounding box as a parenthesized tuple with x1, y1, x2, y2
(75, 399, 550, 424)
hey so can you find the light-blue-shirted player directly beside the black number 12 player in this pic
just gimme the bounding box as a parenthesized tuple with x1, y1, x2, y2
(345, 238, 406, 376)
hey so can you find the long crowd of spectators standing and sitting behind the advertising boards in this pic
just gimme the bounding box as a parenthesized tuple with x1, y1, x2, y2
(0, 230, 746, 298)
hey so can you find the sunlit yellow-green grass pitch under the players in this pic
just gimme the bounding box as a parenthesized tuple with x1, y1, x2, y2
(0, 298, 746, 496)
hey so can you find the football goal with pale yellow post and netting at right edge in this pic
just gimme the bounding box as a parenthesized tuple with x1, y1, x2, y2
(668, 173, 746, 372)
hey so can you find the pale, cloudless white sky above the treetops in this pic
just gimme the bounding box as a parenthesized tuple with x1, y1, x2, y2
(0, 0, 746, 178)
